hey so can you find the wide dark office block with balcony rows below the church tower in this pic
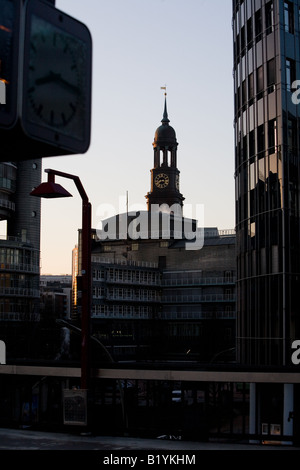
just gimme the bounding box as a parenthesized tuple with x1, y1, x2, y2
(88, 229, 236, 362)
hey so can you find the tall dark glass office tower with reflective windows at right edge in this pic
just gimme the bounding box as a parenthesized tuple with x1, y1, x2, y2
(232, 0, 300, 366)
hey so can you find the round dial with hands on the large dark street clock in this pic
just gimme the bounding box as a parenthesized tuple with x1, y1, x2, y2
(28, 27, 79, 132)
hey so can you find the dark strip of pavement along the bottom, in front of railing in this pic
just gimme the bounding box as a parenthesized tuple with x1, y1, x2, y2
(0, 428, 300, 455)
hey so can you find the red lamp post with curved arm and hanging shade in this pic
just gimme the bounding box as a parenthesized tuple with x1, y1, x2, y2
(30, 169, 92, 390)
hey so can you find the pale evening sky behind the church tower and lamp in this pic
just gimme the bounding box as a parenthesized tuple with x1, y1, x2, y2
(41, 0, 235, 274)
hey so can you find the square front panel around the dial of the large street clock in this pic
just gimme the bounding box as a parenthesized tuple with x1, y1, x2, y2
(23, 2, 91, 153)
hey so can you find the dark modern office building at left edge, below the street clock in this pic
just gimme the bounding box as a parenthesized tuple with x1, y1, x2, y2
(0, 159, 41, 357)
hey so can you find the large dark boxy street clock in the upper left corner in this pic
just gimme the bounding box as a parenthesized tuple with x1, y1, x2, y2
(0, 0, 92, 161)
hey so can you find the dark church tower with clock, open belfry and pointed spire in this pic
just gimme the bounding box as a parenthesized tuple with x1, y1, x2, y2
(146, 97, 184, 212)
